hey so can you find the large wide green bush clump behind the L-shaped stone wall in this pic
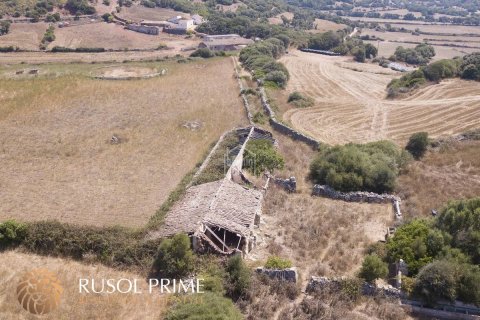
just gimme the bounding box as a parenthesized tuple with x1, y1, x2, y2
(310, 141, 406, 193)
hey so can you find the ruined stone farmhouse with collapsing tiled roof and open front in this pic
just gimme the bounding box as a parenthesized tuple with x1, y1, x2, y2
(154, 127, 276, 255)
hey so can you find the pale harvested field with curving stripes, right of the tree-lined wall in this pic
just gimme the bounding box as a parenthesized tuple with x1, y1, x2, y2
(279, 51, 480, 144)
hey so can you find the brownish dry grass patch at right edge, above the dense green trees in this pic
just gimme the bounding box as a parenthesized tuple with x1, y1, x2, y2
(396, 141, 480, 217)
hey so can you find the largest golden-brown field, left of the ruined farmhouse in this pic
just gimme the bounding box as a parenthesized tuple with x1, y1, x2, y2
(0, 58, 246, 227)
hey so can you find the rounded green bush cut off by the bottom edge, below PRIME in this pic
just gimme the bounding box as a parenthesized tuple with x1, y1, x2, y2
(165, 292, 243, 320)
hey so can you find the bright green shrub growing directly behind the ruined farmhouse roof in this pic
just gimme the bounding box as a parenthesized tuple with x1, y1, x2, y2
(244, 139, 285, 176)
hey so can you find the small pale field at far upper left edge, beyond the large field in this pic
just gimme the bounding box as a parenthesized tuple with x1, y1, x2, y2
(0, 22, 48, 50)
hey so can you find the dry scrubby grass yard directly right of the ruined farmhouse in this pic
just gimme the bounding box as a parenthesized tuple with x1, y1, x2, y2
(251, 134, 394, 281)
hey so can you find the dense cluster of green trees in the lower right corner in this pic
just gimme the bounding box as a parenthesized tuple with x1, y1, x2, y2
(386, 198, 480, 306)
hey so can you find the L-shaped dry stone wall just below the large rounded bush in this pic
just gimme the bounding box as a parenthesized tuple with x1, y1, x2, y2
(312, 184, 402, 219)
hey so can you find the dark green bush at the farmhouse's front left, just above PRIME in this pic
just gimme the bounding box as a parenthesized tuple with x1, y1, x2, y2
(155, 234, 195, 278)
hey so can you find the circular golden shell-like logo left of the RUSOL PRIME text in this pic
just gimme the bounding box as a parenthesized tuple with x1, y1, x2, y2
(17, 269, 63, 315)
